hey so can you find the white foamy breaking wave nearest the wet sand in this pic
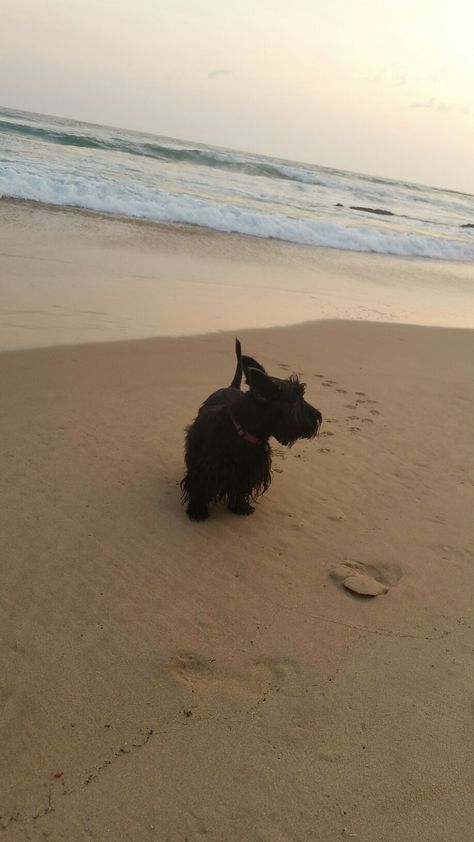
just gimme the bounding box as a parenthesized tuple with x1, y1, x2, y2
(0, 164, 474, 261)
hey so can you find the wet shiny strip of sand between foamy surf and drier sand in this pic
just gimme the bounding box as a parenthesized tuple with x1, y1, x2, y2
(0, 200, 474, 350)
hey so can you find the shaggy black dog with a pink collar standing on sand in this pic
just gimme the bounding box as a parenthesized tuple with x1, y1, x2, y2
(181, 339, 322, 520)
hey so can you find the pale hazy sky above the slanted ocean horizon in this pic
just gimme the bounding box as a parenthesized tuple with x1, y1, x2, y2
(0, 0, 474, 193)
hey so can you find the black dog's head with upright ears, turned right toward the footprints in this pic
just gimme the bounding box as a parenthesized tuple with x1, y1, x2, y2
(242, 357, 323, 447)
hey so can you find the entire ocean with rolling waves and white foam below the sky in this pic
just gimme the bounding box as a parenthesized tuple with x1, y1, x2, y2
(0, 109, 474, 261)
